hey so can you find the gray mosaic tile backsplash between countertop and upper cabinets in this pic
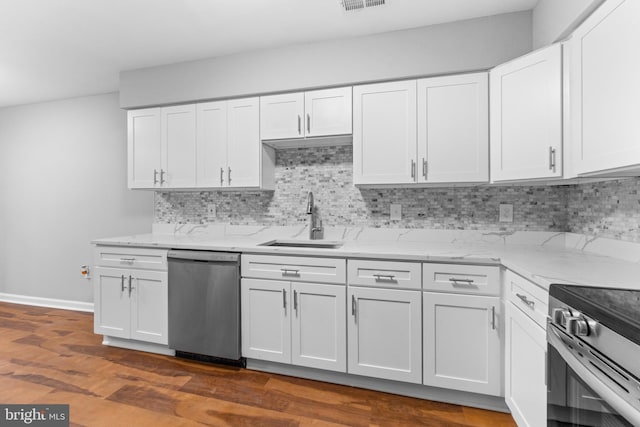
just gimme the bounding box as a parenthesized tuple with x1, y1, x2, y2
(155, 146, 640, 242)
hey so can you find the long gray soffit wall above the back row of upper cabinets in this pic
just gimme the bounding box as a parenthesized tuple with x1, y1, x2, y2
(120, 11, 532, 108)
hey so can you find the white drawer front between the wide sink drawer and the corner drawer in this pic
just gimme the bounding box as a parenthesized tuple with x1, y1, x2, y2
(348, 259, 421, 289)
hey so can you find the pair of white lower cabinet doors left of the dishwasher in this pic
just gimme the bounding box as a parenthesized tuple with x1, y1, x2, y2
(93, 267, 168, 345)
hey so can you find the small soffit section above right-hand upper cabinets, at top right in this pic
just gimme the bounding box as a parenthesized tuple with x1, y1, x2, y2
(533, 0, 604, 49)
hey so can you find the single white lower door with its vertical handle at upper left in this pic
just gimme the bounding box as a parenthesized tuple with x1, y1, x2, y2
(347, 287, 422, 384)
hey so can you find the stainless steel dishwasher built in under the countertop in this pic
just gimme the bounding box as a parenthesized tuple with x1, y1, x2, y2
(167, 250, 241, 364)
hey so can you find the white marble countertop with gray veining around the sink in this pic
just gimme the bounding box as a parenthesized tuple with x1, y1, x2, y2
(91, 224, 640, 290)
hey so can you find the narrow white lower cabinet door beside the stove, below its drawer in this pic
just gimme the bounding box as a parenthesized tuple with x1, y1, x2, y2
(505, 303, 547, 427)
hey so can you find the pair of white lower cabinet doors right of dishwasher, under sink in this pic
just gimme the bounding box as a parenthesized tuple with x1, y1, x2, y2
(241, 278, 347, 372)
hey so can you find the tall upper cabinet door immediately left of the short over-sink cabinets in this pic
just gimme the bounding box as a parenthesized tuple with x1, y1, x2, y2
(226, 98, 262, 187)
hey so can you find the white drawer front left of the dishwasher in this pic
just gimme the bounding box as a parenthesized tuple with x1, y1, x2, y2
(93, 246, 167, 270)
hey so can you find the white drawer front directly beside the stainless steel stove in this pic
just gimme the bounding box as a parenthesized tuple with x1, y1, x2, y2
(504, 270, 549, 329)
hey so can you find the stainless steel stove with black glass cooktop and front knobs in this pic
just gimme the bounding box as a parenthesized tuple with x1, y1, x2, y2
(547, 284, 640, 427)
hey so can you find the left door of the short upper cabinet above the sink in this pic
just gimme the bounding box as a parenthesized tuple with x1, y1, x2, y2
(260, 92, 304, 140)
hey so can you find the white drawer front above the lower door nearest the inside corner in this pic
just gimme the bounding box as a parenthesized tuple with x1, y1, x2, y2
(422, 263, 500, 295)
